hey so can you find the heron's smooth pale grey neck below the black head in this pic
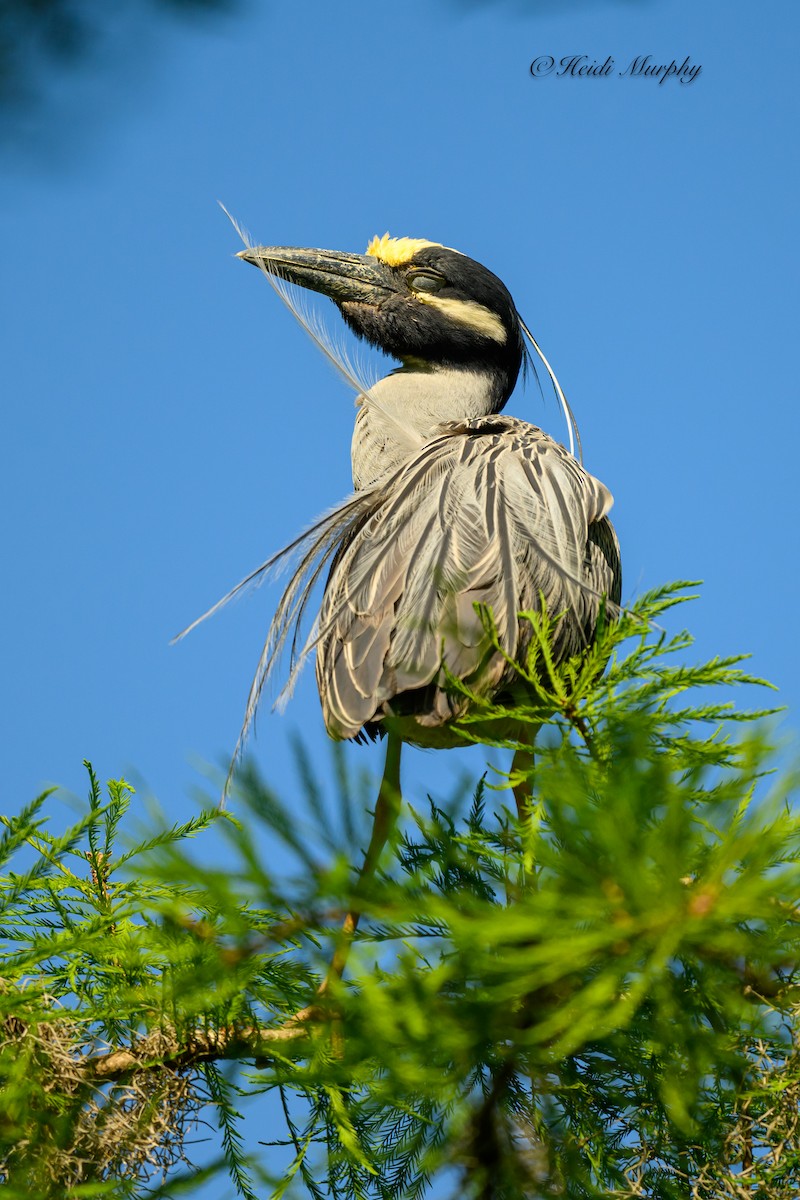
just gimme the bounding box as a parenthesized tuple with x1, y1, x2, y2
(351, 365, 510, 488)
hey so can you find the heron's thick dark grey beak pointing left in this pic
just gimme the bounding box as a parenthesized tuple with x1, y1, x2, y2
(236, 246, 397, 304)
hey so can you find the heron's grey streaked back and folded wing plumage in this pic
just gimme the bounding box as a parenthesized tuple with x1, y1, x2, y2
(317, 416, 619, 737)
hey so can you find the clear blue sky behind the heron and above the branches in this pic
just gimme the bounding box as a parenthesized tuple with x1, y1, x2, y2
(0, 0, 800, 1180)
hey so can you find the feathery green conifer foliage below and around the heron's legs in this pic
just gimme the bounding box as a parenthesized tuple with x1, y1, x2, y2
(0, 587, 800, 1200)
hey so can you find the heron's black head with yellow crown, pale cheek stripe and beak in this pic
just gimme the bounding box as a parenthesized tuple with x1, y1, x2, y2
(239, 234, 524, 401)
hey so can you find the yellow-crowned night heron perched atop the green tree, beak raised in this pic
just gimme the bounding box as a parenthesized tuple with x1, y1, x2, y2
(179, 235, 621, 984)
